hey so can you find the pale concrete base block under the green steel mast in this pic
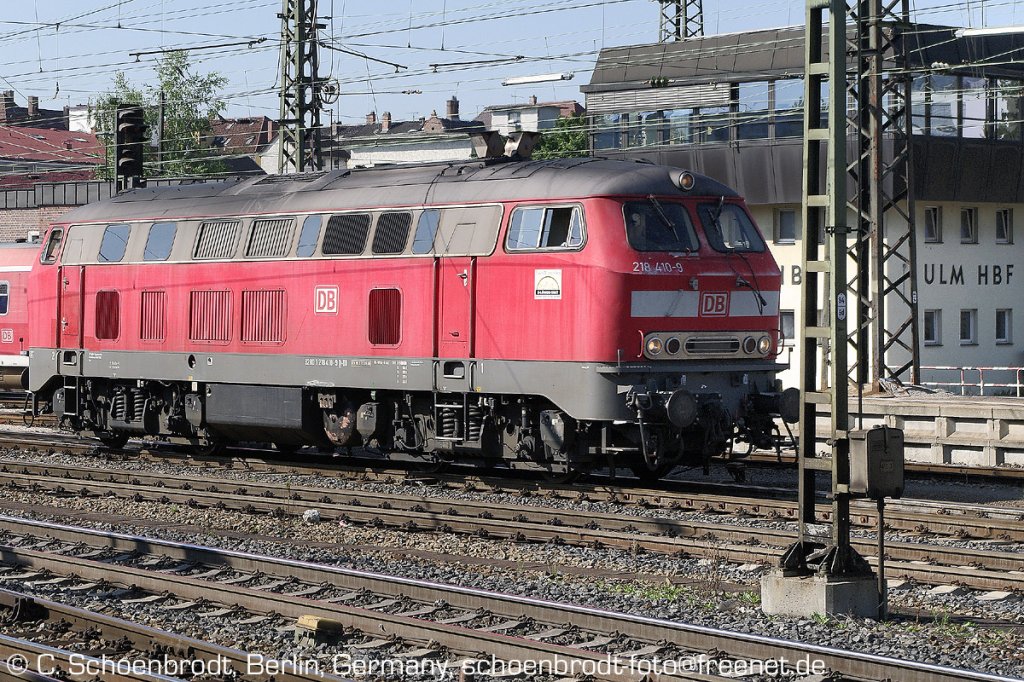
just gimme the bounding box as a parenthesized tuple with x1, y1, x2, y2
(761, 570, 879, 619)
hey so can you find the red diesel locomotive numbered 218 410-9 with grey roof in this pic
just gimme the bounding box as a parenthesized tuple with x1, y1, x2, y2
(24, 159, 780, 476)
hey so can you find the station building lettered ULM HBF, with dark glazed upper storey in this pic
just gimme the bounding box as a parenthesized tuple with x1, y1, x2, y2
(582, 25, 1024, 395)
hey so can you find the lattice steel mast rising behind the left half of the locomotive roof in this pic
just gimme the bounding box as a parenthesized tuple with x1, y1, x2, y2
(278, 0, 325, 173)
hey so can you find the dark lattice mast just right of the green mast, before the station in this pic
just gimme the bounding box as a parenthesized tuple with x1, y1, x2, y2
(847, 0, 921, 391)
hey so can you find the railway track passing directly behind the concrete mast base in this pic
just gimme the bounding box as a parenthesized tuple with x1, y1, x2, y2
(0, 454, 1024, 590)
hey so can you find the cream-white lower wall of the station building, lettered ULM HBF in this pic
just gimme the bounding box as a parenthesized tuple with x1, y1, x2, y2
(751, 202, 1024, 394)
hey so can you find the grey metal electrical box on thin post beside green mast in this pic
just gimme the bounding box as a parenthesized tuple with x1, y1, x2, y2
(850, 426, 903, 500)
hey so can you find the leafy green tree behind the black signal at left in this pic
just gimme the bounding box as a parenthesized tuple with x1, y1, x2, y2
(89, 51, 227, 179)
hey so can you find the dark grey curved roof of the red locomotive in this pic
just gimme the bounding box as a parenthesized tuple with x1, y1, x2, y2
(60, 159, 737, 223)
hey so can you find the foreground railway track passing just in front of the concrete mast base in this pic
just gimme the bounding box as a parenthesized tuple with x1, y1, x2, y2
(0, 518, 1008, 682)
